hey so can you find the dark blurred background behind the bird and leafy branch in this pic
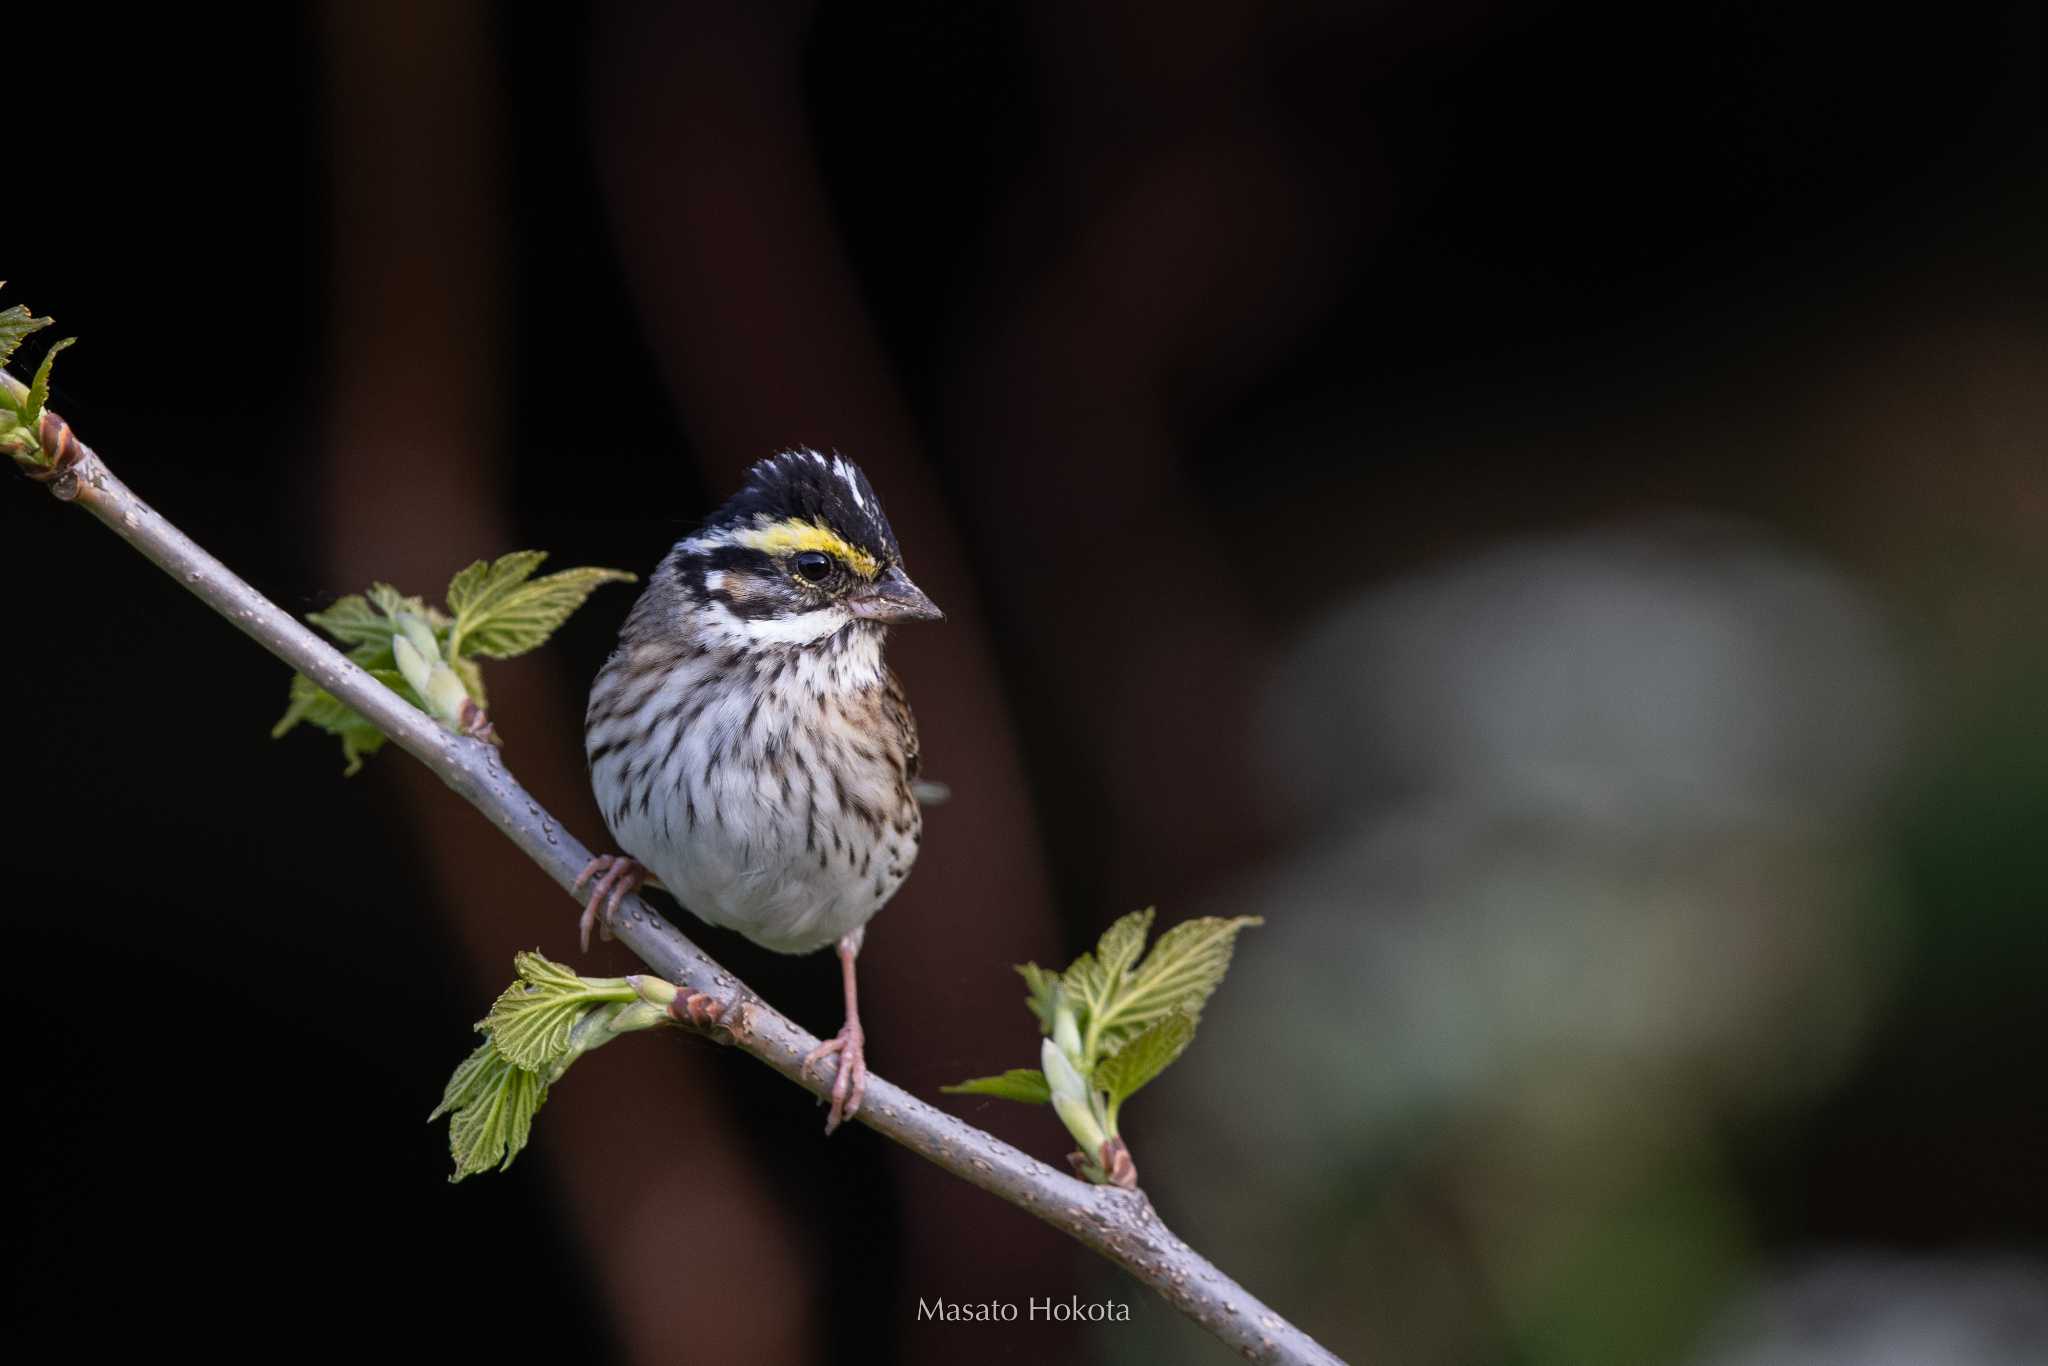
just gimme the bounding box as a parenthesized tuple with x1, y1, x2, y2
(0, 0, 2048, 1366)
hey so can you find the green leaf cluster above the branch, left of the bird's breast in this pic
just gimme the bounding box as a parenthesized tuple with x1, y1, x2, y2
(270, 551, 633, 774)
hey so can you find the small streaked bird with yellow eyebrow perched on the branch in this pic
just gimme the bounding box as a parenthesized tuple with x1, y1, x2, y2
(578, 451, 942, 1135)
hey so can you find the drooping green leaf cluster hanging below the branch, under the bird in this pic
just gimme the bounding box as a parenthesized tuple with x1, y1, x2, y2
(426, 952, 668, 1182)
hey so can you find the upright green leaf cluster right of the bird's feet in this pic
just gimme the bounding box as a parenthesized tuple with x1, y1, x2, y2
(944, 907, 1262, 1180)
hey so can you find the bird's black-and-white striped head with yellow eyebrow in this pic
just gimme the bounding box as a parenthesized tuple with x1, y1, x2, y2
(668, 451, 942, 645)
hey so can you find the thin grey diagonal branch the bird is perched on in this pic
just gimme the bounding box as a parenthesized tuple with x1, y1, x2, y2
(16, 371, 1337, 1364)
